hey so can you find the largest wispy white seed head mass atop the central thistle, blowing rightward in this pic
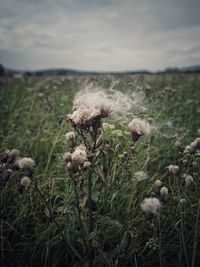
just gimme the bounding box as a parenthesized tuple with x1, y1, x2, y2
(68, 83, 144, 125)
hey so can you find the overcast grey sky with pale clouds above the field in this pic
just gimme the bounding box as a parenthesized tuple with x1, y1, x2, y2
(0, 0, 200, 71)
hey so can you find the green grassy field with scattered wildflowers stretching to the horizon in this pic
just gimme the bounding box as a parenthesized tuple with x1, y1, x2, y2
(0, 74, 200, 267)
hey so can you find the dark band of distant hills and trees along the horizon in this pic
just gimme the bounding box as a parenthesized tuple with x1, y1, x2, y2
(0, 63, 200, 76)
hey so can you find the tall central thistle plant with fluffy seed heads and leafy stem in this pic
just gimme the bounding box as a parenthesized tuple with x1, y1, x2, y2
(63, 86, 152, 266)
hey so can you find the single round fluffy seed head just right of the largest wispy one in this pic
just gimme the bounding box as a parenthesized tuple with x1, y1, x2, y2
(128, 118, 152, 136)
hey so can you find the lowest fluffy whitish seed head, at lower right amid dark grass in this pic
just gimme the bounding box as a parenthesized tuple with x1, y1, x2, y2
(140, 197, 161, 215)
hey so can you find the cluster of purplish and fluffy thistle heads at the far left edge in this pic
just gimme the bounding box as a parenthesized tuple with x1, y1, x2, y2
(0, 149, 35, 193)
